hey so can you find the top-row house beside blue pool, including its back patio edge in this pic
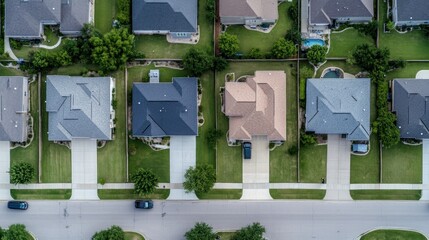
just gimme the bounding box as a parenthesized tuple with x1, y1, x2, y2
(303, 0, 374, 30)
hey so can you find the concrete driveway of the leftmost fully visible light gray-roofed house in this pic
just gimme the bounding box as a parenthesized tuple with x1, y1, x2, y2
(70, 139, 99, 200)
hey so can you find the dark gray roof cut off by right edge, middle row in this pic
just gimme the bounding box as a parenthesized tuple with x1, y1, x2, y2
(393, 79, 429, 139)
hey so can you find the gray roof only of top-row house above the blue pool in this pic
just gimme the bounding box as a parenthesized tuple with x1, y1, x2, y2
(309, 0, 374, 24)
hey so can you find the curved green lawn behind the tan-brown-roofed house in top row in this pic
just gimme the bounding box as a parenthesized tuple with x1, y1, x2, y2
(227, 1, 296, 54)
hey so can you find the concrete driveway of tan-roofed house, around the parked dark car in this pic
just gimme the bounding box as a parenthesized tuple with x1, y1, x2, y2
(241, 136, 272, 200)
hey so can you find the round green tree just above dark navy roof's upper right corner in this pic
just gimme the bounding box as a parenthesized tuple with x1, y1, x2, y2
(183, 48, 213, 77)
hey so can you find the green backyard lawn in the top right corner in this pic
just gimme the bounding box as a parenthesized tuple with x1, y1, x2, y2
(379, 1, 429, 60)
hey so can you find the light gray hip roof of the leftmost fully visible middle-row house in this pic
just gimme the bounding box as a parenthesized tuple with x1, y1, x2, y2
(46, 75, 112, 141)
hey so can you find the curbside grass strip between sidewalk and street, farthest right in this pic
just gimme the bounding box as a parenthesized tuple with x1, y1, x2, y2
(350, 190, 422, 200)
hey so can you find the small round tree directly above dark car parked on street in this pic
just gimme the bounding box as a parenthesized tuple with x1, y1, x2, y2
(131, 168, 158, 196)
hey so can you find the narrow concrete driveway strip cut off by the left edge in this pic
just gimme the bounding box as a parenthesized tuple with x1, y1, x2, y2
(0, 141, 12, 200)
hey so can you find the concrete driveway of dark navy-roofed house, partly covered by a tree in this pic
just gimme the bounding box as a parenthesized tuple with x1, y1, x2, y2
(168, 136, 198, 200)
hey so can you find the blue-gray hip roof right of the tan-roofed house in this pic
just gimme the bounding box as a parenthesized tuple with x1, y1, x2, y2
(305, 78, 370, 140)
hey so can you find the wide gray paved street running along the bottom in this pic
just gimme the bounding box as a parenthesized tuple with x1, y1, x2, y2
(0, 201, 429, 240)
